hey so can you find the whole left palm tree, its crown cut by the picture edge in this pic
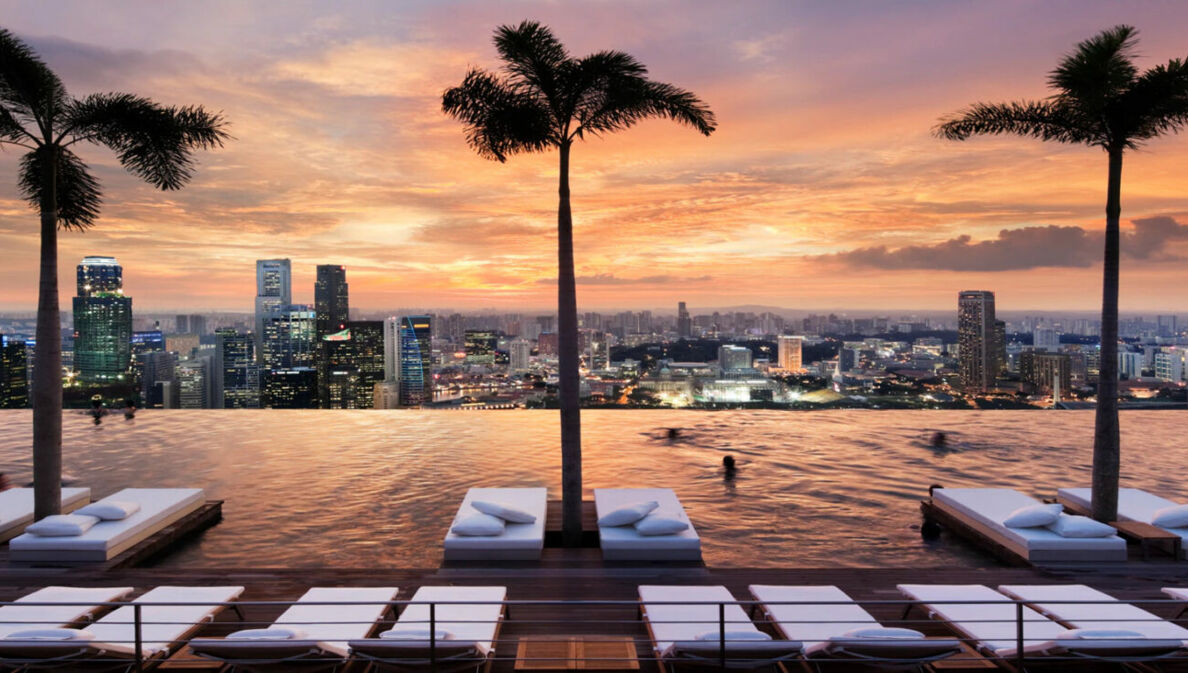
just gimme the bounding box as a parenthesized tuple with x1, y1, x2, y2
(0, 29, 227, 518)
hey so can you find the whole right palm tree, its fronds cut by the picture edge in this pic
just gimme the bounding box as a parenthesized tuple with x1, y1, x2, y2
(936, 25, 1188, 521)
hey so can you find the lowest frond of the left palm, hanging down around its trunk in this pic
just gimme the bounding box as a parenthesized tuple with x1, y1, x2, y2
(19, 145, 102, 231)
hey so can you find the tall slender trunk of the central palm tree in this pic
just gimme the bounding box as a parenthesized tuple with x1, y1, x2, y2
(557, 143, 582, 547)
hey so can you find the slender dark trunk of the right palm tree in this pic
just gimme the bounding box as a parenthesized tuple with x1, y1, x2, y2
(1093, 147, 1123, 522)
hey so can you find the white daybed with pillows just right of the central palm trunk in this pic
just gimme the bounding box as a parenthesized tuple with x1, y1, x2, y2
(594, 489, 701, 561)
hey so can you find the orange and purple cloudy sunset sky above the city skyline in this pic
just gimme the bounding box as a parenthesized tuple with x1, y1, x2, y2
(0, 0, 1188, 314)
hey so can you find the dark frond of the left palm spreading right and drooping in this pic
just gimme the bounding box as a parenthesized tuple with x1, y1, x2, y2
(63, 94, 229, 189)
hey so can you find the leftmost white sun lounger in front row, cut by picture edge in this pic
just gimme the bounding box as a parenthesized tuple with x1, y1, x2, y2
(0, 586, 132, 639)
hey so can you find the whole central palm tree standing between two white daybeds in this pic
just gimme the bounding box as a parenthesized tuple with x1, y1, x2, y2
(442, 21, 716, 546)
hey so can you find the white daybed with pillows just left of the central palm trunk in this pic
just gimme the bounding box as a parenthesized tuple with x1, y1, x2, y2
(444, 488, 549, 561)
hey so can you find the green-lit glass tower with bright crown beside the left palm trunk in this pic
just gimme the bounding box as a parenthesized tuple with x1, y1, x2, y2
(74, 257, 132, 383)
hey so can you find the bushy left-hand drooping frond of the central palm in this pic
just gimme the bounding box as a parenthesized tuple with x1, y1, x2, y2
(442, 69, 557, 162)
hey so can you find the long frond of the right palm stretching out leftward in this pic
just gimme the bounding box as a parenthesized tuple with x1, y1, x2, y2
(933, 100, 1108, 145)
